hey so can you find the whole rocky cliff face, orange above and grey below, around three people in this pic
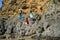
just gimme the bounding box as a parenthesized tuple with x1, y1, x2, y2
(0, 0, 60, 40)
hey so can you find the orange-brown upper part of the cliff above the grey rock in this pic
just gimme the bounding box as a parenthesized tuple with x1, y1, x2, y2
(0, 0, 50, 16)
